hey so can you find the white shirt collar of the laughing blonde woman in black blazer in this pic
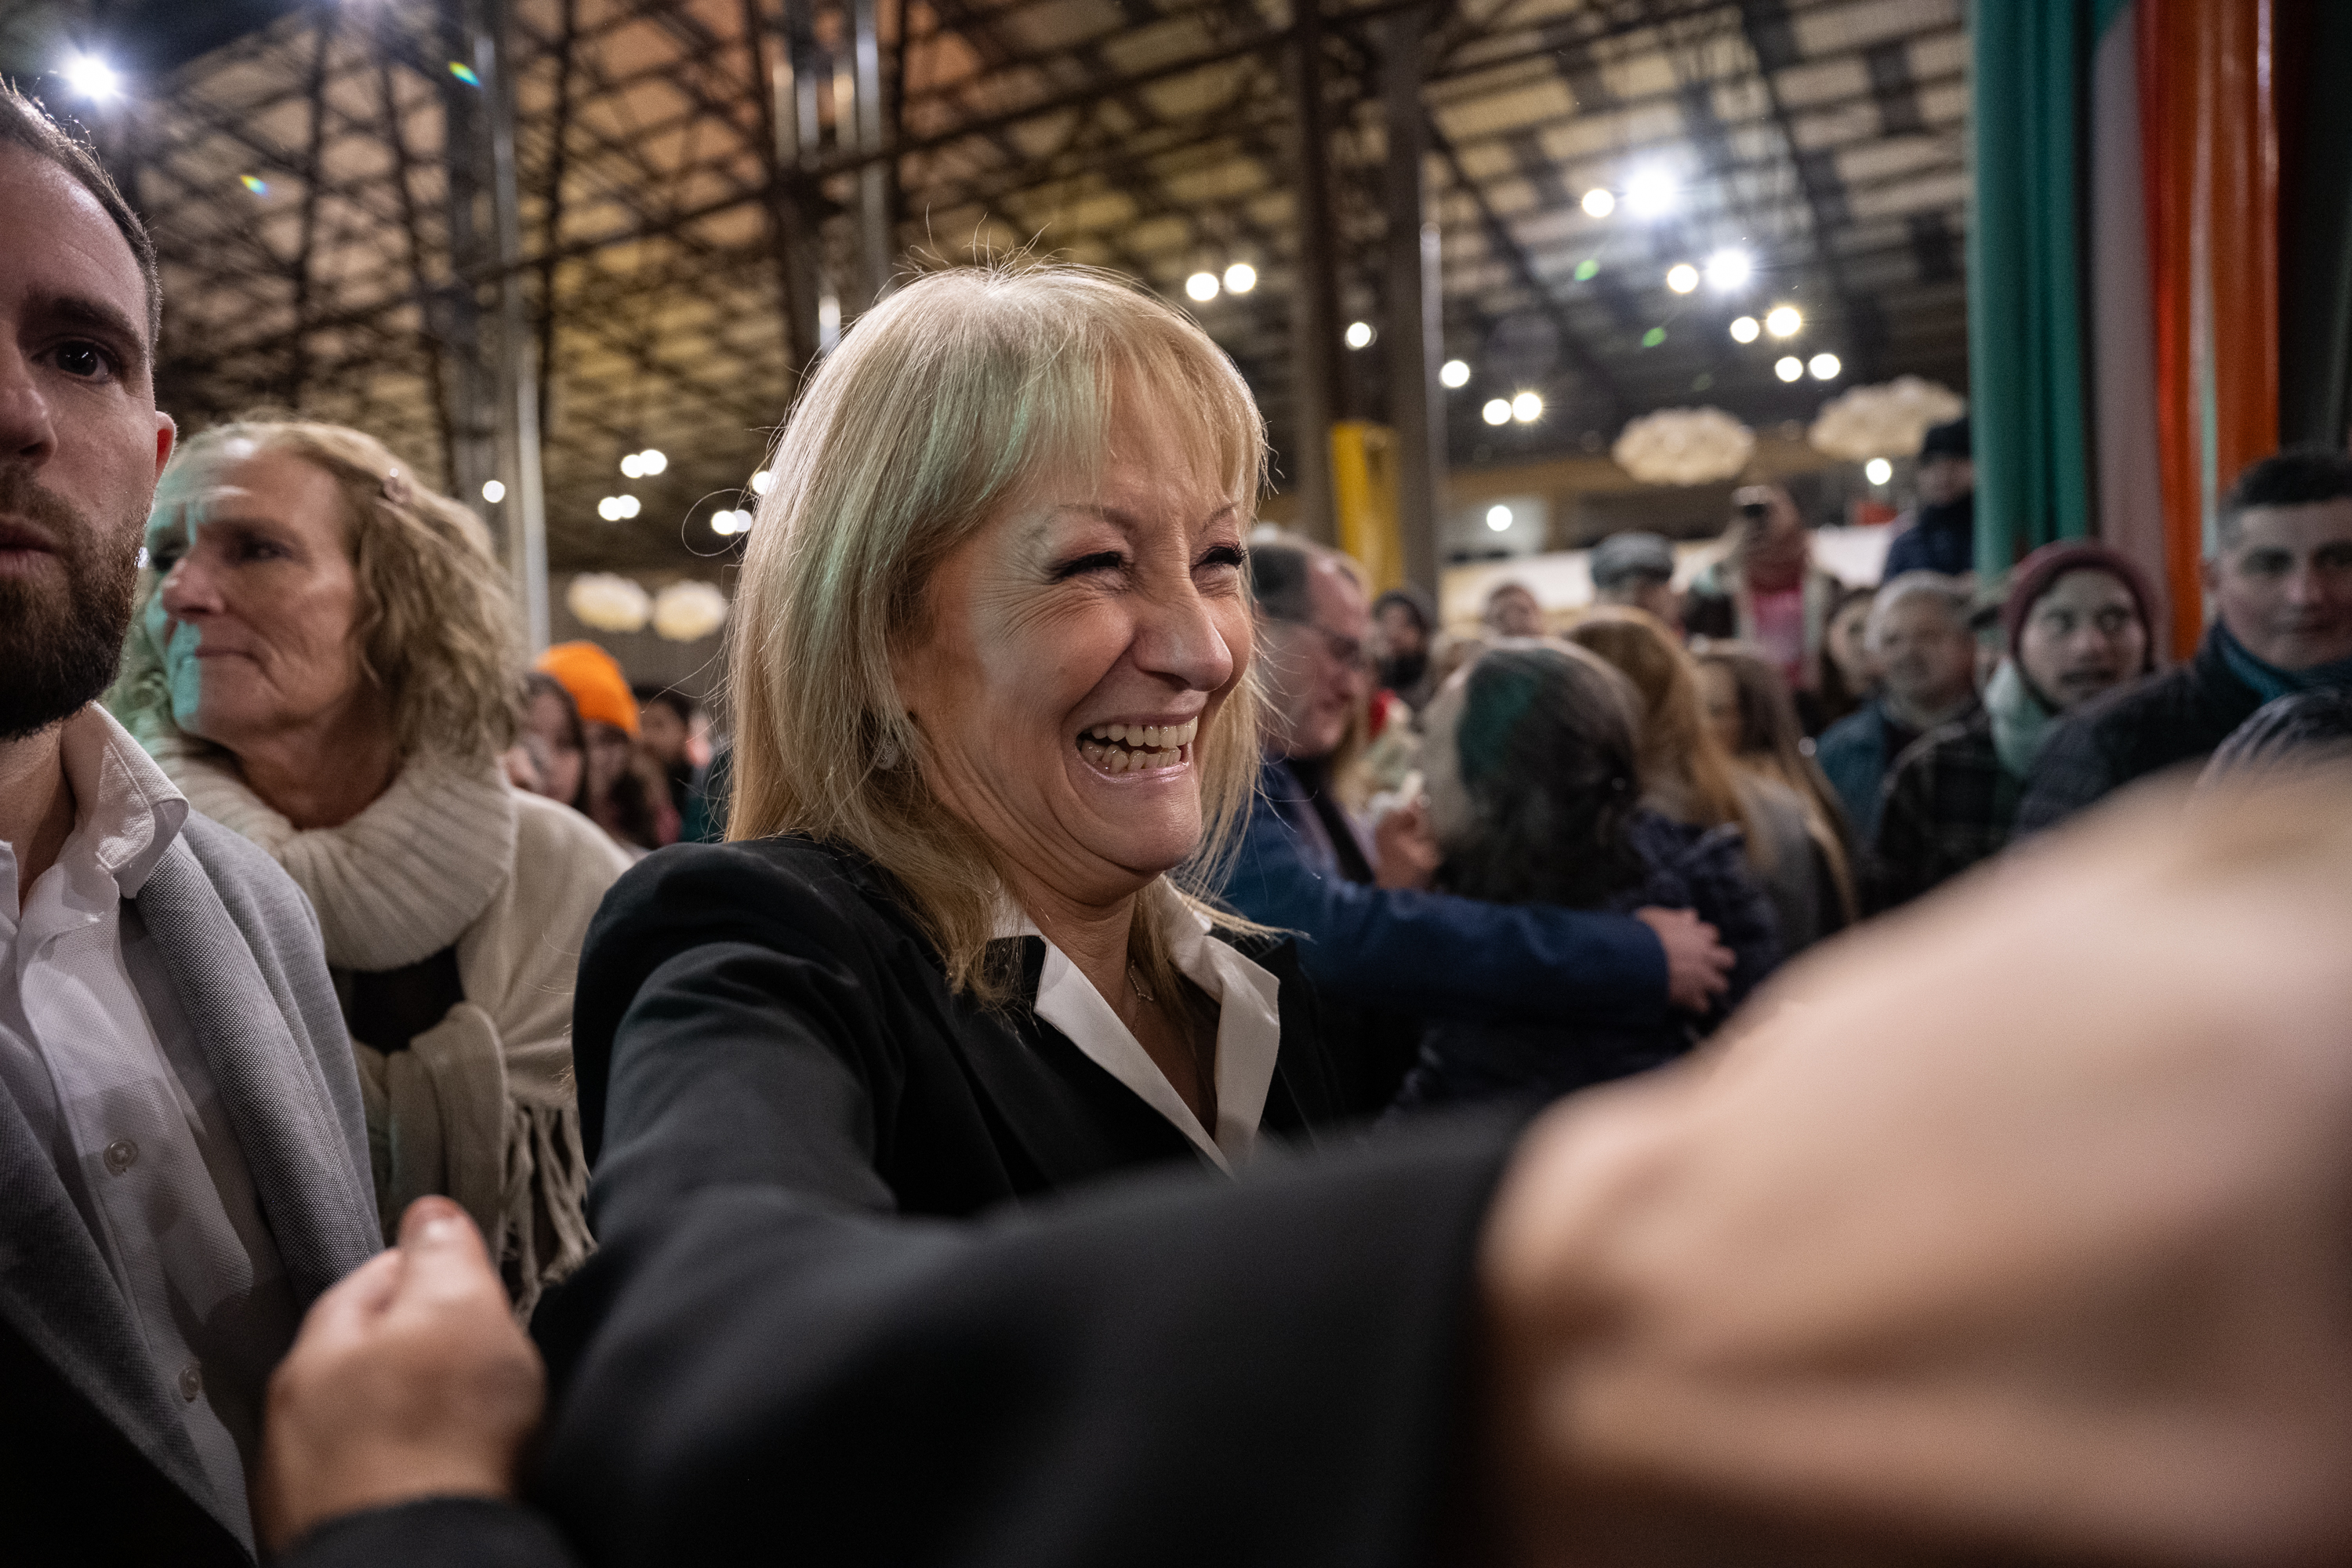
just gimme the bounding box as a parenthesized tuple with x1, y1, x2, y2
(997, 877, 1282, 1173)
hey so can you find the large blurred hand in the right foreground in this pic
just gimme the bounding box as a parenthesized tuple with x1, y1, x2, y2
(1479, 771, 2352, 1568)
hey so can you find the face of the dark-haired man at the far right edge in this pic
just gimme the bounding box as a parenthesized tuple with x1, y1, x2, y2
(2206, 499, 2352, 670)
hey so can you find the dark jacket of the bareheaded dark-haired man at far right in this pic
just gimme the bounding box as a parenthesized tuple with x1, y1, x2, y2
(2018, 621, 2263, 837)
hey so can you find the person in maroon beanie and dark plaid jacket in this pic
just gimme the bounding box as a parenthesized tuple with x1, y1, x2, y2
(1863, 541, 2154, 912)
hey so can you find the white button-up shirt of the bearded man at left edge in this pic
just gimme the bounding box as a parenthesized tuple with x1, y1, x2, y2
(0, 703, 296, 1544)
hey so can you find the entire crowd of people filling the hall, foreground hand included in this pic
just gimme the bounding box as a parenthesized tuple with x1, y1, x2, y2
(0, 89, 2352, 1568)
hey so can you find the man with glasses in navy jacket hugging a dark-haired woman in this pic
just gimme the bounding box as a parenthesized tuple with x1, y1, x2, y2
(1225, 543, 1731, 1109)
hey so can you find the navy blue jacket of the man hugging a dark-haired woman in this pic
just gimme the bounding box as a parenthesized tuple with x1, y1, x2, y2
(1225, 762, 1668, 1048)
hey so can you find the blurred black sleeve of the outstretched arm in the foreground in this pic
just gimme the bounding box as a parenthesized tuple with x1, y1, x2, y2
(532, 1123, 1510, 1568)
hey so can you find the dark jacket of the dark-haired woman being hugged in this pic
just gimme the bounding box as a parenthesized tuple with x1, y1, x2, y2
(1397, 811, 1780, 1109)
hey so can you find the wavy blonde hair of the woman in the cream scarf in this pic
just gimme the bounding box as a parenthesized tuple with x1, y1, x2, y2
(108, 419, 522, 767)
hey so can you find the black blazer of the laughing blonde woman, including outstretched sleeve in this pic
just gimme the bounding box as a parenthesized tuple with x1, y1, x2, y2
(285, 839, 1510, 1568)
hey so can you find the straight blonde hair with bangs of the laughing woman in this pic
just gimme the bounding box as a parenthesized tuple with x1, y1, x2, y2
(727, 263, 1265, 1001)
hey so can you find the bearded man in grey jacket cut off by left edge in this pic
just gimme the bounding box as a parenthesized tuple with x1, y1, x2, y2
(0, 85, 379, 1563)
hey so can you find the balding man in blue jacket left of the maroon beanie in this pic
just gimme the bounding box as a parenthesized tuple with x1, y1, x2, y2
(1813, 572, 1976, 844)
